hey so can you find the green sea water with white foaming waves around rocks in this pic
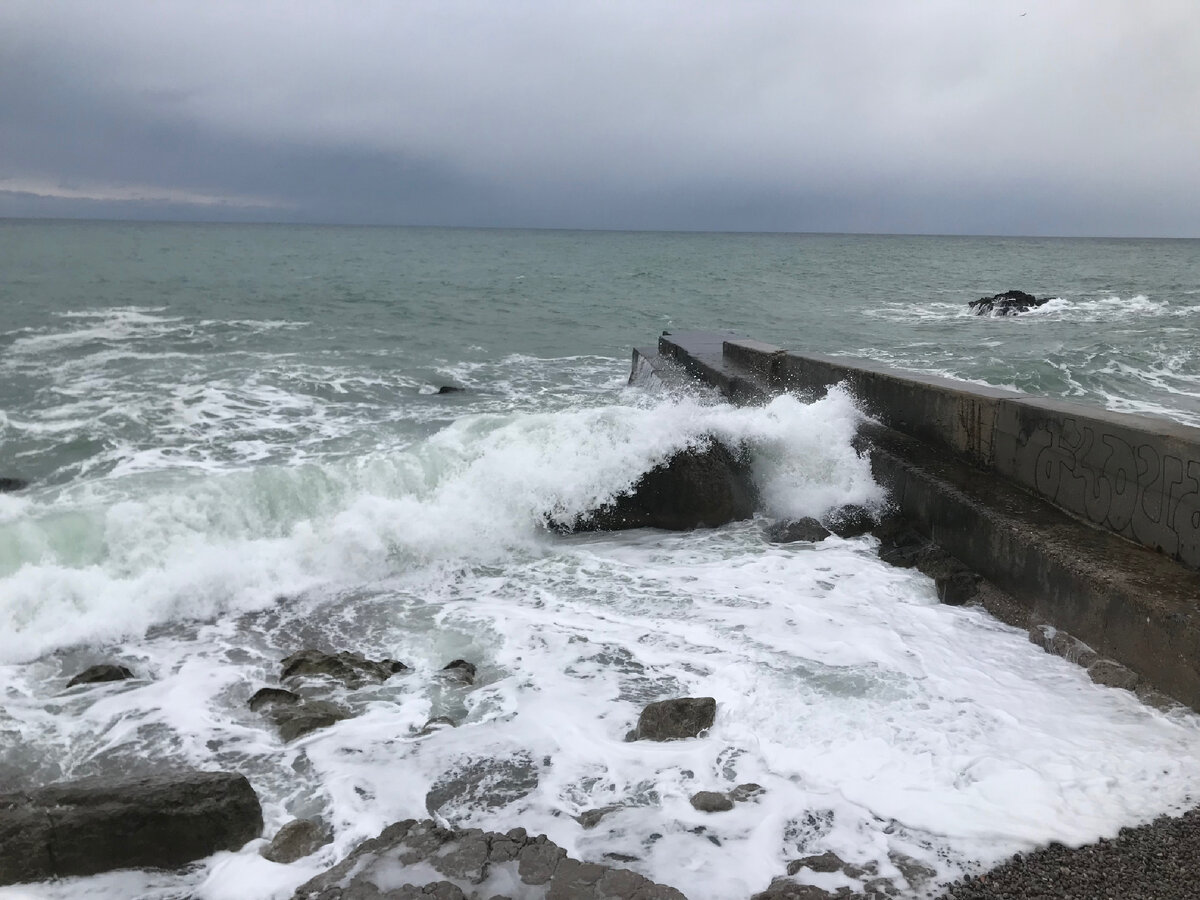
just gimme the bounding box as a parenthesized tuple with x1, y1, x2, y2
(0, 222, 1200, 900)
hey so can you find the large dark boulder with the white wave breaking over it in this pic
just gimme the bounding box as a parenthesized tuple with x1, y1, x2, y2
(571, 440, 755, 532)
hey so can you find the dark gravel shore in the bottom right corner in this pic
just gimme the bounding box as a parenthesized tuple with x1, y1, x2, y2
(942, 809, 1200, 900)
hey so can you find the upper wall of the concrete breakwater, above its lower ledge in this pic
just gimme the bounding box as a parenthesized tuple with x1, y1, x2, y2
(658, 331, 1200, 569)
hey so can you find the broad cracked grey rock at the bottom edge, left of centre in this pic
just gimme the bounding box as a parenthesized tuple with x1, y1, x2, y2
(294, 820, 684, 900)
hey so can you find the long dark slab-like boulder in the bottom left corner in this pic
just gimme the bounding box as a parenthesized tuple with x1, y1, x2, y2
(0, 770, 263, 884)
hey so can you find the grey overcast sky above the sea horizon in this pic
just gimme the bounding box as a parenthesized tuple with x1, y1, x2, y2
(0, 0, 1200, 236)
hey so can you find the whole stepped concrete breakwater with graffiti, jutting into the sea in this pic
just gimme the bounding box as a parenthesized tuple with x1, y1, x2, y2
(634, 331, 1200, 709)
